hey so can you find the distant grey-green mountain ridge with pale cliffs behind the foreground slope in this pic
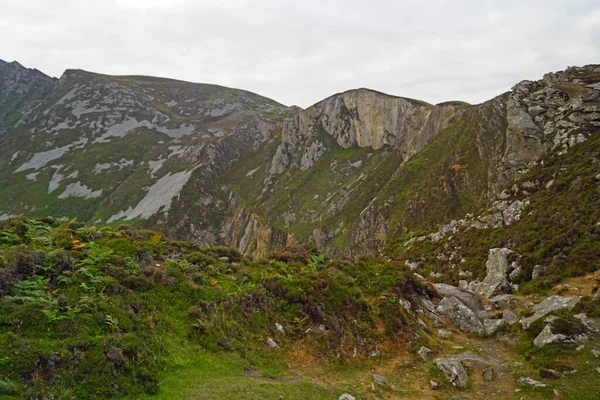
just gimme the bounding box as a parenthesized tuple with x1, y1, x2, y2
(0, 63, 600, 256)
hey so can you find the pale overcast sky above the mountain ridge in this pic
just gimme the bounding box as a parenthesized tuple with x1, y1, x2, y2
(0, 0, 600, 107)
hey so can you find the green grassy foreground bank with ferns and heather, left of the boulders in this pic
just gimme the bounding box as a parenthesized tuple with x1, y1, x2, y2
(0, 220, 432, 399)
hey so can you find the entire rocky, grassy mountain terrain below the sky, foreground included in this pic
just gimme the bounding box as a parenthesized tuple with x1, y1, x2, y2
(0, 62, 600, 400)
